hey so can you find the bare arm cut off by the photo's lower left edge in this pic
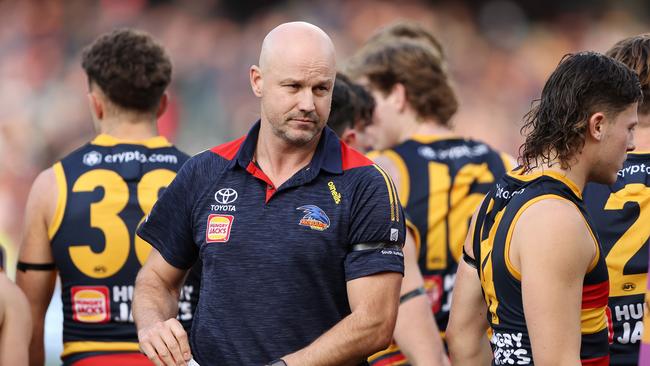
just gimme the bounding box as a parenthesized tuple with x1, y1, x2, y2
(0, 272, 31, 366)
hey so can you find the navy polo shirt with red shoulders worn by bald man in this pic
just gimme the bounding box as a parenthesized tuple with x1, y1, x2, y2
(138, 122, 405, 366)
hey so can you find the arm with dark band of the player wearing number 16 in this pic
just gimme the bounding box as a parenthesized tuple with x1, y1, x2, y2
(393, 230, 449, 366)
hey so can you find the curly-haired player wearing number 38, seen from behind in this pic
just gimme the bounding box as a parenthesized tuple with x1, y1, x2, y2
(17, 30, 199, 366)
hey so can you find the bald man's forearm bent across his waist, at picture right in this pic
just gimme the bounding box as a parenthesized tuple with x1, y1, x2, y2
(283, 312, 395, 366)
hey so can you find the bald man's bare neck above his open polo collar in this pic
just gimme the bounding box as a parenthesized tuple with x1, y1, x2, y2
(255, 123, 322, 187)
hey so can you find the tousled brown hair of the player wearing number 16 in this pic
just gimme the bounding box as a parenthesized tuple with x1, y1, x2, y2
(349, 39, 458, 126)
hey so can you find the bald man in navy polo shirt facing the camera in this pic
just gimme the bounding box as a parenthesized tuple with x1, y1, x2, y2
(133, 22, 405, 366)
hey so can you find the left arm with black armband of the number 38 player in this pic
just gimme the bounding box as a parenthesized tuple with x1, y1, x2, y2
(16, 168, 58, 366)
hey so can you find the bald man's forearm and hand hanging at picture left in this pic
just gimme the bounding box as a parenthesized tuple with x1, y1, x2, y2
(133, 248, 192, 366)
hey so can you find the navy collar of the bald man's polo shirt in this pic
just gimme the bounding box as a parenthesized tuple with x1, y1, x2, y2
(228, 120, 343, 174)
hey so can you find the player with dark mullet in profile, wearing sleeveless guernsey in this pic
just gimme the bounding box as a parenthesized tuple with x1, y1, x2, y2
(447, 52, 642, 366)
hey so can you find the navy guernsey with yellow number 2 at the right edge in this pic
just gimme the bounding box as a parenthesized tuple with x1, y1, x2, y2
(584, 152, 650, 366)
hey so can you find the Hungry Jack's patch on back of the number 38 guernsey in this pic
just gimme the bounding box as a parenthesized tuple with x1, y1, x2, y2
(70, 286, 111, 323)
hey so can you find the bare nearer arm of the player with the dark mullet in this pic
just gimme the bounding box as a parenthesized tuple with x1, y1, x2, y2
(510, 199, 596, 366)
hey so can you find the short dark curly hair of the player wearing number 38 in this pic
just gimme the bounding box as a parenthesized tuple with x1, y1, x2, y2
(81, 29, 172, 112)
